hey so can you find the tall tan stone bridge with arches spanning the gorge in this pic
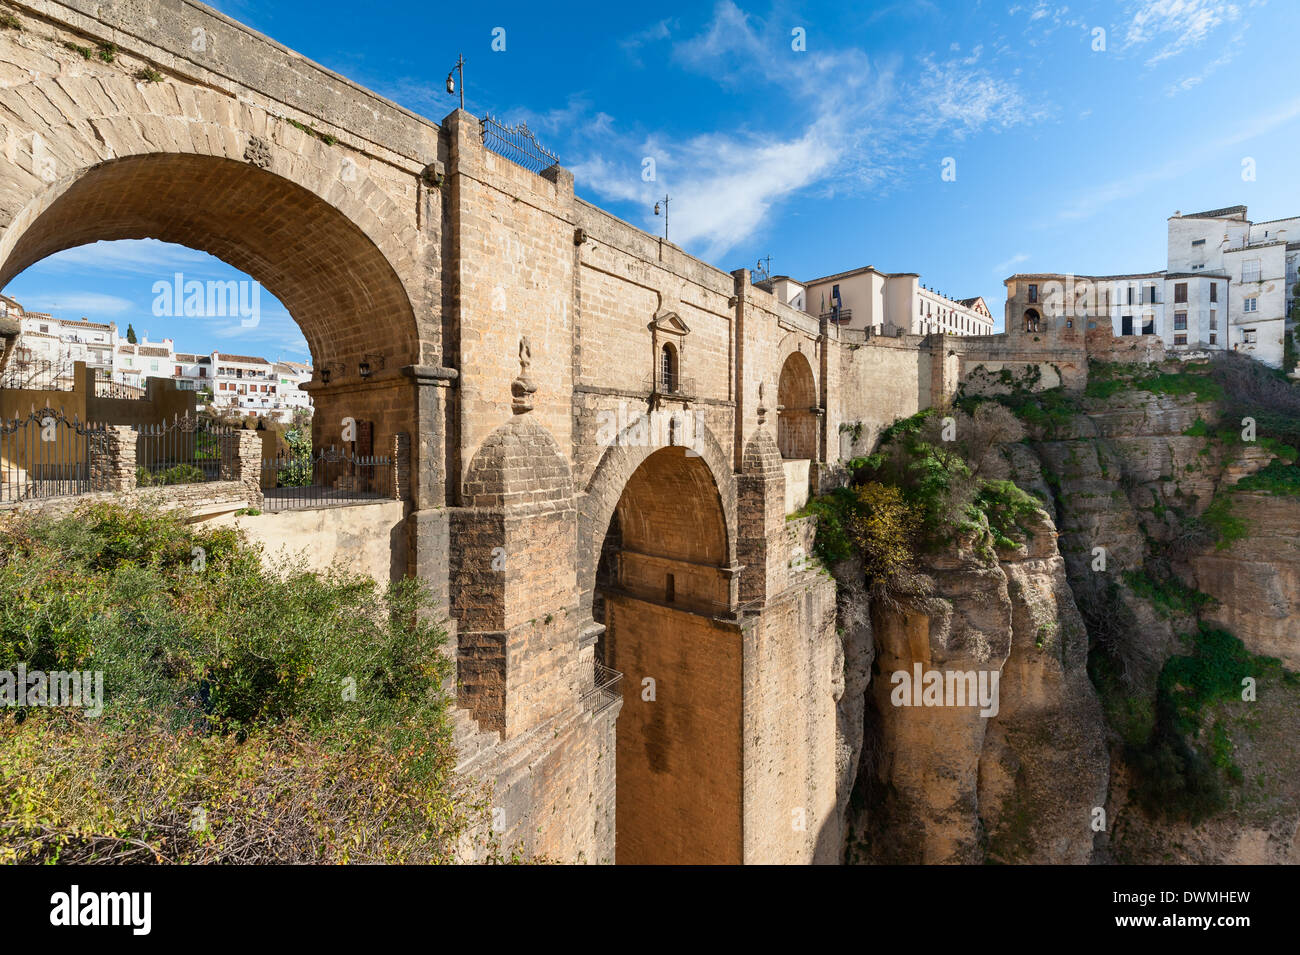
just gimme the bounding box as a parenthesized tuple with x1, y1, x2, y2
(0, 0, 952, 863)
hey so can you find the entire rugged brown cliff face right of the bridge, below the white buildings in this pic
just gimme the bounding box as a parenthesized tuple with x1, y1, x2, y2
(837, 374, 1300, 863)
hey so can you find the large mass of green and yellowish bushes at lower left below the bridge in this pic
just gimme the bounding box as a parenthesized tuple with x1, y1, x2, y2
(0, 504, 482, 861)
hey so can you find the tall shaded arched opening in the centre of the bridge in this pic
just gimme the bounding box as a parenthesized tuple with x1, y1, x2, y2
(593, 447, 742, 864)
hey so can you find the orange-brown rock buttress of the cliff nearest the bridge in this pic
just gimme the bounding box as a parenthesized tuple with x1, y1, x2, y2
(849, 504, 1108, 863)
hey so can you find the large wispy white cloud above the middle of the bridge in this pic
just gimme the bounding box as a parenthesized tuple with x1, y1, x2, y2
(548, 0, 1045, 259)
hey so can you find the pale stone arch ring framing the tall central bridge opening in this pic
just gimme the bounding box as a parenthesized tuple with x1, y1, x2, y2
(577, 417, 738, 612)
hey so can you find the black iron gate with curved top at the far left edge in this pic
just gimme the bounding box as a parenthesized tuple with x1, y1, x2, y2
(0, 408, 108, 504)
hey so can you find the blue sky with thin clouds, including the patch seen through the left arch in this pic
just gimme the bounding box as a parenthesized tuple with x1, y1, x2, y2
(5, 0, 1300, 359)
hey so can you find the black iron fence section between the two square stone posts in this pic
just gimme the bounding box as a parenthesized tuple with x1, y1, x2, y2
(134, 414, 239, 487)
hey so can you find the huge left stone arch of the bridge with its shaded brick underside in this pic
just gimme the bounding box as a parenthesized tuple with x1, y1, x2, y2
(0, 63, 426, 369)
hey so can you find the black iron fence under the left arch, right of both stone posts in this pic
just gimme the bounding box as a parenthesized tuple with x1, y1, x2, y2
(261, 447, 394, 511)
